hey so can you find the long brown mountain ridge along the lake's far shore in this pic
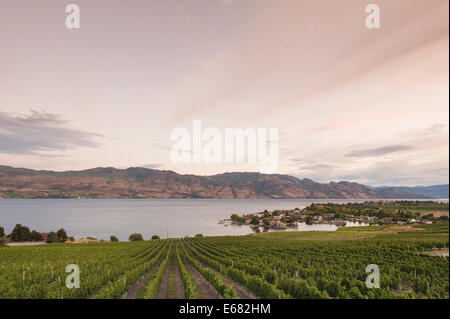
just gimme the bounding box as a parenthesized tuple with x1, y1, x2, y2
(0, 166, 436, 199)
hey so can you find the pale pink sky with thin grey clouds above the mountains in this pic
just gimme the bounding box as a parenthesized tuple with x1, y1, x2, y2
(0, 0, 449, 186)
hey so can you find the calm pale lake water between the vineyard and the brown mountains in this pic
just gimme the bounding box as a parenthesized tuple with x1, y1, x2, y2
(0, 199, 372, 240)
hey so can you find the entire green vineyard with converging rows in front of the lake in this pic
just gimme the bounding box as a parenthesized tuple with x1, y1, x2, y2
(0, 223, 449, 299)
